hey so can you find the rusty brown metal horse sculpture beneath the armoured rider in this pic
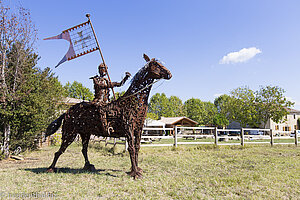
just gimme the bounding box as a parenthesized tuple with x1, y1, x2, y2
(46, 54, 172, 178)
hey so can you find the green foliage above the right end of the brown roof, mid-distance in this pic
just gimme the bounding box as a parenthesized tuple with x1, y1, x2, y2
(184, 98, 217, 125)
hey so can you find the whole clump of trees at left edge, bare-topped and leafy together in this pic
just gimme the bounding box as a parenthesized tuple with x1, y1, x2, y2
(0, 2, 62, 156)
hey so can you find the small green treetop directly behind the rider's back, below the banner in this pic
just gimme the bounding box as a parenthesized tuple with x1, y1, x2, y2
(64, 81, 94, 101)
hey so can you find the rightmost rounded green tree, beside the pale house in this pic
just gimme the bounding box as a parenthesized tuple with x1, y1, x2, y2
(255, 86, 294, 126)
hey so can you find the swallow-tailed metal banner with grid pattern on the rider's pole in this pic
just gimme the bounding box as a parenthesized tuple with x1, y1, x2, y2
(44, 21, 99, 68)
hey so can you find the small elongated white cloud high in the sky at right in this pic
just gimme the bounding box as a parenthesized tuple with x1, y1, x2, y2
(219, 47, 262, 64)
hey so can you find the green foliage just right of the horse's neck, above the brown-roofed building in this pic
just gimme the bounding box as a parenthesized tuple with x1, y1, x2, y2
(148, 93, 185, 118)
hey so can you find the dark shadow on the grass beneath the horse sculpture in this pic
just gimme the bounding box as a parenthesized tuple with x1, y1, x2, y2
(23, 167, 122, 177)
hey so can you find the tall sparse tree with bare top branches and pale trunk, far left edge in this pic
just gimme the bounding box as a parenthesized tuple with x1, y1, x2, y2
(0, 2, 36, 156)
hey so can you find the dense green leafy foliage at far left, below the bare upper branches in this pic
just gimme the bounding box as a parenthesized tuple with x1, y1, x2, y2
(0, 50, 63, 150)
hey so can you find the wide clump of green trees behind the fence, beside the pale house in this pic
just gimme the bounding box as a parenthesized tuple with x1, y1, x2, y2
(214, 86, 293, 127)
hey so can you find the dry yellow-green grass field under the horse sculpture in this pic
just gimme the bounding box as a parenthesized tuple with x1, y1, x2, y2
(0, 144, 300, 199)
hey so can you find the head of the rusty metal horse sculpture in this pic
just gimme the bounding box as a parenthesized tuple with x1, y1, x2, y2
(144, 54, 172, 80)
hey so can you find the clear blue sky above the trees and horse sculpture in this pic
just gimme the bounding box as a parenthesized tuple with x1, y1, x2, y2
(7, 0, 300, 109)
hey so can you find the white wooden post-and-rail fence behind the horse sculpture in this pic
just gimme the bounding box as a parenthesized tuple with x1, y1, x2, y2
(90, 127, 300, 150)
